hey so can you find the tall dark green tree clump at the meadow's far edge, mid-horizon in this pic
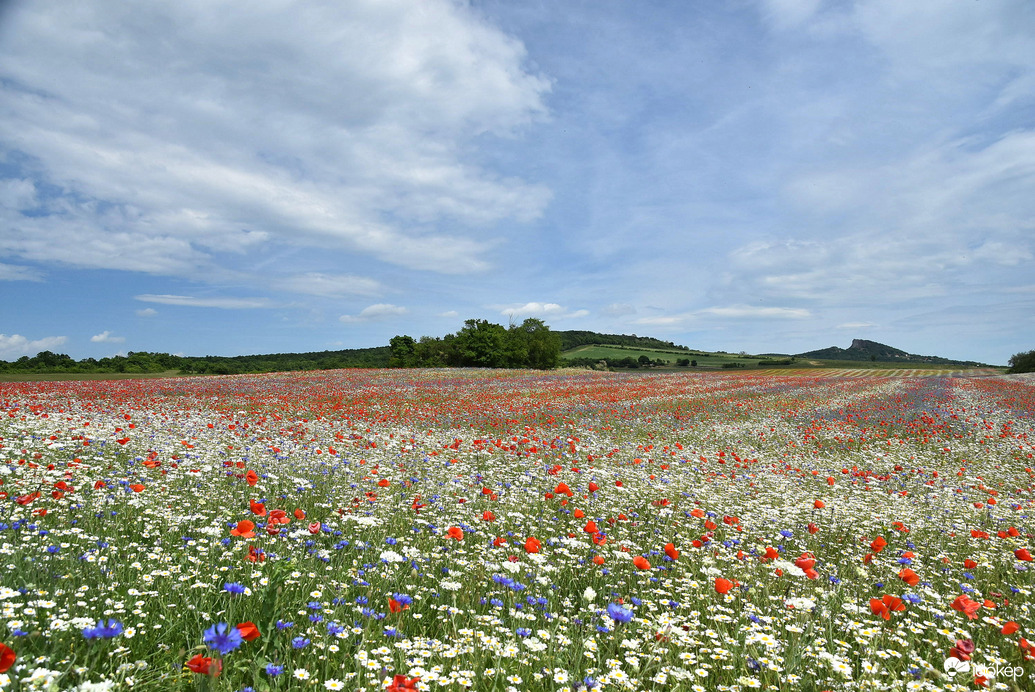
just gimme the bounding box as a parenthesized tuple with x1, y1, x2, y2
(388, 318, 561, 369)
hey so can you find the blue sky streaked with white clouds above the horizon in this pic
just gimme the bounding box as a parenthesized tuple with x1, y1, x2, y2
(0, 0, 1035, 363)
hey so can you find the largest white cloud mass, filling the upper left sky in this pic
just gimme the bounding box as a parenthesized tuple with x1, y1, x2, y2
(0, 0, 551, 281)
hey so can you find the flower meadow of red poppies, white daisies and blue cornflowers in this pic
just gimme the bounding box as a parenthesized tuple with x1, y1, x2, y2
(0, 370, 1035, 692)
